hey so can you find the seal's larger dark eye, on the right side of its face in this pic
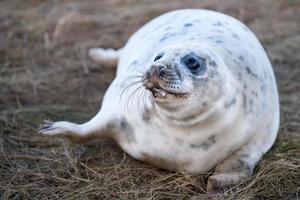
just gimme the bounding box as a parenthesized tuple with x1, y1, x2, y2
(180, 53, 206, 75)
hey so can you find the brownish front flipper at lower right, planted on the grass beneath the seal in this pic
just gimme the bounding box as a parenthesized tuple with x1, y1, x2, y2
(207, 145, 263, 195)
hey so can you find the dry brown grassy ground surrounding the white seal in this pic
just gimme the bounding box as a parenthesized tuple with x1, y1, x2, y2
(0, 0, 300, 200)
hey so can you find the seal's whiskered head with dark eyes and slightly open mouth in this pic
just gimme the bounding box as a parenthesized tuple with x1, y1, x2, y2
(143, 45, 224, 113)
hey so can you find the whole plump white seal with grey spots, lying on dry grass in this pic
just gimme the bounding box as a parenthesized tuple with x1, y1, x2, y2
(40, 9, 279, 193)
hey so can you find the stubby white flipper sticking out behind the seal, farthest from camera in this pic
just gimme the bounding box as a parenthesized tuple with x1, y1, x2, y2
(89, 48, 122, 67)
